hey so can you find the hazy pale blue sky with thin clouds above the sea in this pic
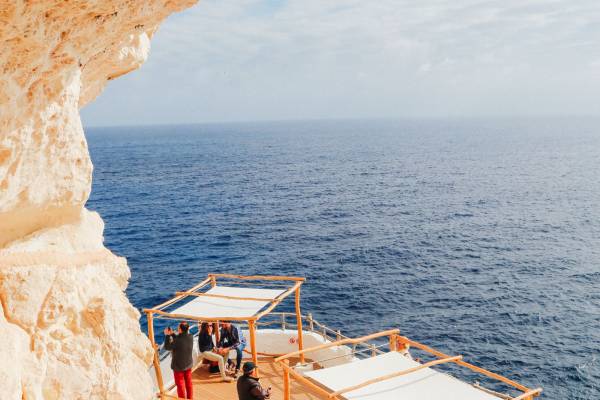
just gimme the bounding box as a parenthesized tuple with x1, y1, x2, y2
(82, 0, 600, 126)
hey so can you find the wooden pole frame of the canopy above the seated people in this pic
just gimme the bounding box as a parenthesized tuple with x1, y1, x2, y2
(144, 274, 306, 396)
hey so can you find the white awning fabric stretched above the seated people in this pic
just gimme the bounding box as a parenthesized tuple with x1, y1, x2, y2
(170, 285, 285, 319)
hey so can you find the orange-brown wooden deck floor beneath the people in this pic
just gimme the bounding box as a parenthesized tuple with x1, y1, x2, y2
(163, 358, 323, 400)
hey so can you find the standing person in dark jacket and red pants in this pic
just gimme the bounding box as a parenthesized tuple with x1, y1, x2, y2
(164, 322, 194, 399)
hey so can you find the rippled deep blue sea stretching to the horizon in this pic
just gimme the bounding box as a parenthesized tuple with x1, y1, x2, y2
(87, 119, 600, 400)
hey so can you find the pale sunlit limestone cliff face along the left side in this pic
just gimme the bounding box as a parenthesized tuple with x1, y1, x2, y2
(0, 0, 196, 400)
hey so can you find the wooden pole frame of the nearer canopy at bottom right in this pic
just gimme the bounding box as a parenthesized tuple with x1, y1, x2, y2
(275, 329, 542, 400)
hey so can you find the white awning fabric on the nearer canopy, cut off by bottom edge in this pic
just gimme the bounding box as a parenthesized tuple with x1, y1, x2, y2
(305, 352, 498, 400)
